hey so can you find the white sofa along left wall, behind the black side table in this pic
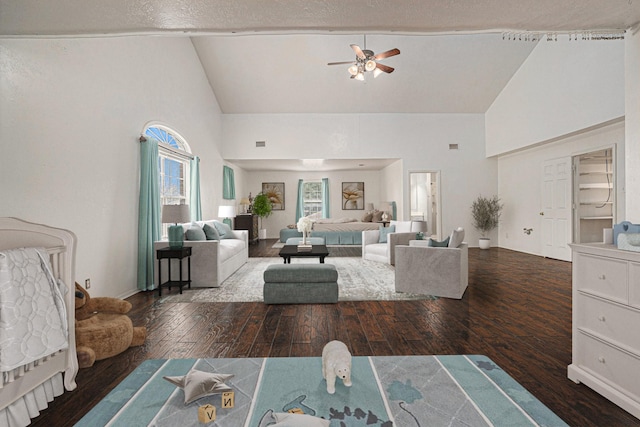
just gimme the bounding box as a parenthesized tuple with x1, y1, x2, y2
(154, 220, 249, 288)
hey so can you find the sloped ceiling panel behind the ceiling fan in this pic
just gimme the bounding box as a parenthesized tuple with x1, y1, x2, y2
(193, 34, 535, 113)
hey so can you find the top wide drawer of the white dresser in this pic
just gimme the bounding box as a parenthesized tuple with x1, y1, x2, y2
(574, 253, 629, 304)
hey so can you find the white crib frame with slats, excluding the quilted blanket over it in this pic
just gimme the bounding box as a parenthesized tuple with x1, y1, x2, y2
(0, 218, 78, 427)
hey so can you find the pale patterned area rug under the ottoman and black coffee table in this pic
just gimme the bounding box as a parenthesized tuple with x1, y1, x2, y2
(163, 257, 430, 303)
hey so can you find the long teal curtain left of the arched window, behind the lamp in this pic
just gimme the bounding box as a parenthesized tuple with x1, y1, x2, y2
(138, 136, 161, 291)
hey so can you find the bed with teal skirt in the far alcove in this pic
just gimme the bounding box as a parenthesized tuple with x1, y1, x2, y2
(280, 218, 383, 245)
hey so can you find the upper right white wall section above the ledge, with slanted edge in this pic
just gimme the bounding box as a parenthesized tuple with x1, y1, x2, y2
(485, 39, 624, 156)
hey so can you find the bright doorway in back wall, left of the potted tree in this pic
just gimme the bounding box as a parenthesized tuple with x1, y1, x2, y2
(409, 171, 441, 238)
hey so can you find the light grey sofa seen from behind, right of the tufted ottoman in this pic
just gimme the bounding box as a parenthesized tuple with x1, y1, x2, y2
(395, 228, 469, 299)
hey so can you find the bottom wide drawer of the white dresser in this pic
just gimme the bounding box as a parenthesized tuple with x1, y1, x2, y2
(573, 332, 640, 401)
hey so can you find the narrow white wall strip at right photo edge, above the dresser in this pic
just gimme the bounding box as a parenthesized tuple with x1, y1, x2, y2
(624, 26, 640, 224)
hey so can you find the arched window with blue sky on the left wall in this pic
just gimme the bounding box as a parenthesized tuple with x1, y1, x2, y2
(144, 124, 193, 205)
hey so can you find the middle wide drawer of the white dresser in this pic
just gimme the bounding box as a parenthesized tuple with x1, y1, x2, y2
(574, 293, 640, 354)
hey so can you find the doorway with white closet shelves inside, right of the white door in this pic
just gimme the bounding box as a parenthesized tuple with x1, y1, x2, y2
(573, 147, 616, 243)
